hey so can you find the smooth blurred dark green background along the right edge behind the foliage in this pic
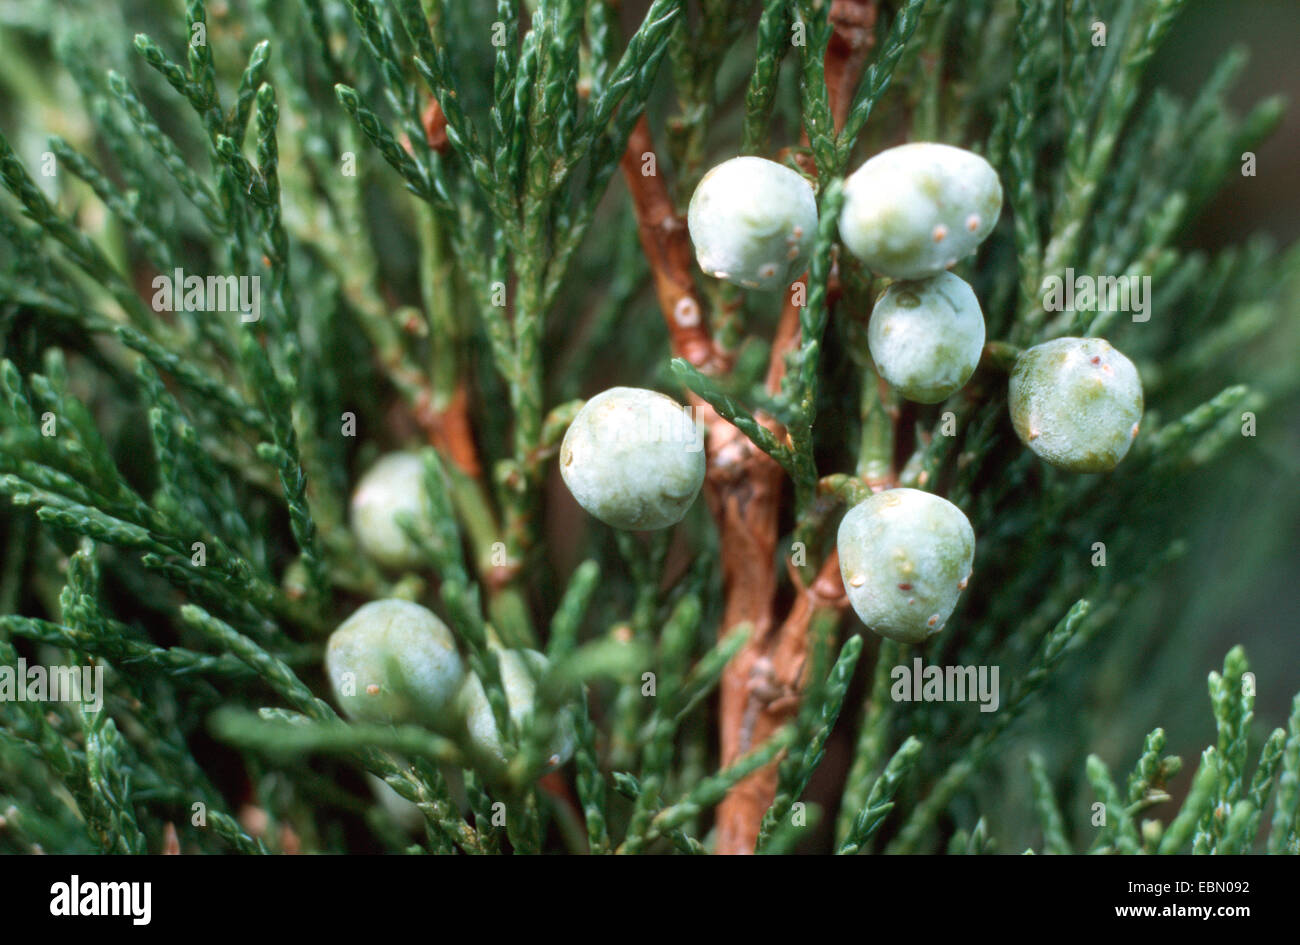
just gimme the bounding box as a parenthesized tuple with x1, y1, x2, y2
(982, 0, 1300, 853)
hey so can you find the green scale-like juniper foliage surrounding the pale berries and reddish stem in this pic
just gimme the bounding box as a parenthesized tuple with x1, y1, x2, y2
(0, 0, 1300, 854)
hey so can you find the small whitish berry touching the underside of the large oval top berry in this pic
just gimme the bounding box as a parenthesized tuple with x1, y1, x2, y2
(867, 273, 984, 403)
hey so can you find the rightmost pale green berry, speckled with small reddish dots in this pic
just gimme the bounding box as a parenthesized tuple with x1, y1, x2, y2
(1008, 338, 1143, 472)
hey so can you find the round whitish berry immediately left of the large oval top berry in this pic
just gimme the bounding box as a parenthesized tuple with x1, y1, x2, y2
(686, 157, 816, 289)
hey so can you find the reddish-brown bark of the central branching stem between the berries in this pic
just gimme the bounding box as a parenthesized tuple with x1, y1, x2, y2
(623, 0, 876, 854)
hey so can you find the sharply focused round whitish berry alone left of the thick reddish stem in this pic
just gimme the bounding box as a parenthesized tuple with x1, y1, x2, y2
(560, 387, 705, 529)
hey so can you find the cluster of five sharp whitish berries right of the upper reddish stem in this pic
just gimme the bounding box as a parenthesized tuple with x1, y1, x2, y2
(676, 142, 1141, 643)
